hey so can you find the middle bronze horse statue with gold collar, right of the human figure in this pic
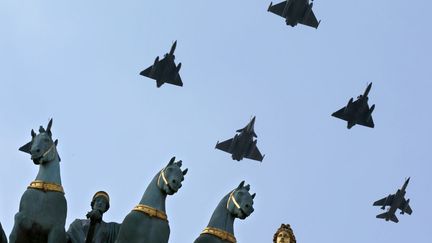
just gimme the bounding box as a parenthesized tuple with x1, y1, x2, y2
(116, 157, 188, 243)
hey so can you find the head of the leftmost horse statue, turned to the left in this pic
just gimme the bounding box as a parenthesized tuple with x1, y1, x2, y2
(19, 119, 60, 165)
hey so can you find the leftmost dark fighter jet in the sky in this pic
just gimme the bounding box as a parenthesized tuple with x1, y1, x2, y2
(140, 41, 183, 88)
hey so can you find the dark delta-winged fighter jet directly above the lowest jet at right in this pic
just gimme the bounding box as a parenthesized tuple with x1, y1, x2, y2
(332, 83, 375, 129)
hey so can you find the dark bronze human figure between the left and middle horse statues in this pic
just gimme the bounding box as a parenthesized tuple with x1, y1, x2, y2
(67, 191, 120, 243)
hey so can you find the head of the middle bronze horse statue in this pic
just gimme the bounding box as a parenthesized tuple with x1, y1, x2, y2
(157, 157, 188, 195)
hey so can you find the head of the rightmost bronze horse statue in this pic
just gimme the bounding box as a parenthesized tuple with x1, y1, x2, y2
(226, 181, 256, 219)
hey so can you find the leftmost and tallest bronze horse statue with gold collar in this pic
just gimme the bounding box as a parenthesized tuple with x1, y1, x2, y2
(9, 119, 67, 243)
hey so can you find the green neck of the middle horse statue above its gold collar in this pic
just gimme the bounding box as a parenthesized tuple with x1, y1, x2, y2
(140, 173, 167, 212)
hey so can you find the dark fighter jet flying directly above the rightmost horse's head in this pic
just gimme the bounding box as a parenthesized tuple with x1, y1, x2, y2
(216, 117, 264, 162)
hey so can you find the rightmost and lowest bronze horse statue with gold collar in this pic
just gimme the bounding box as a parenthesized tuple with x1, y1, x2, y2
(194, 181, 255, 243)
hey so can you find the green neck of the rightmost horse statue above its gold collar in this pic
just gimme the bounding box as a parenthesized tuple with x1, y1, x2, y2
(207, 194, 235, 234)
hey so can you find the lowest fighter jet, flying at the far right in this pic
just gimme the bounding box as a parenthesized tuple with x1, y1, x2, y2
(373, 178, 412, 223)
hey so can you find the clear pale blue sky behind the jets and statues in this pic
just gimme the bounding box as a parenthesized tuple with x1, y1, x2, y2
(0, 0, 432, 243)
